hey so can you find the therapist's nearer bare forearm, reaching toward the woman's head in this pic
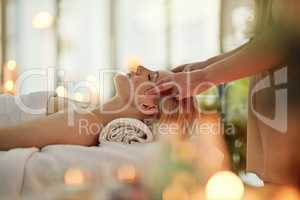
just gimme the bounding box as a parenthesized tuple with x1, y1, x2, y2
(201, 34, 283, 85)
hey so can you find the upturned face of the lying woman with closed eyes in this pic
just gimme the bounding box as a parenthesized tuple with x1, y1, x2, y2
(114, 66, 171, 112)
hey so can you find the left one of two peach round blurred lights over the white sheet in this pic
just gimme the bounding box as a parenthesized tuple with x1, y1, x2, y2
(64, 169, 86, 186)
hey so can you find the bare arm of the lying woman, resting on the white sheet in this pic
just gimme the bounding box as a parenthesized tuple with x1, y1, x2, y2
(0, 108, 102, 150)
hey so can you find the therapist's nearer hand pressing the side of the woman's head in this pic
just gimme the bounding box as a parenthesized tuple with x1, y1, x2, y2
(146, 70, 212, 100)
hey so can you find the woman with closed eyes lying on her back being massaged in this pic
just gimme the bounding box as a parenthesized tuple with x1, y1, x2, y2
(0, 66, 229, 151)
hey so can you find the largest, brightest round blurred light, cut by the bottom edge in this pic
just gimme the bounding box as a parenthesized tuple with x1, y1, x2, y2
(205, 171, 244, 200)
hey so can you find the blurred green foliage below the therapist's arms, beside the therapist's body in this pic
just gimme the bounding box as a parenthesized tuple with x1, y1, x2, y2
(197, 79, 249, 172)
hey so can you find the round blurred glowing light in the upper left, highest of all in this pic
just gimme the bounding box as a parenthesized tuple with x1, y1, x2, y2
(32, 11, 54, 29)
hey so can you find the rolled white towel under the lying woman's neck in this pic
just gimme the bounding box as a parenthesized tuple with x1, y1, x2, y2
(99, 118, 154, 144)
